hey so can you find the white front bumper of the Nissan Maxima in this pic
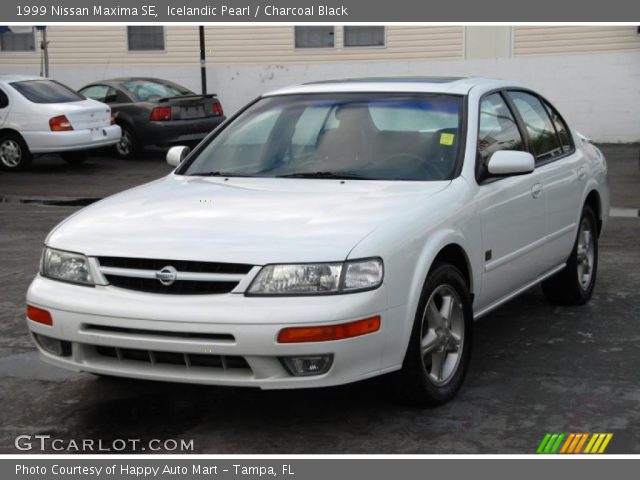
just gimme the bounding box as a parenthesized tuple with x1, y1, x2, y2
(27, 276, 404, 389)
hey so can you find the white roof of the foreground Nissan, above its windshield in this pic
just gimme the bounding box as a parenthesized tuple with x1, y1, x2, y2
(265, 77, 522, 96)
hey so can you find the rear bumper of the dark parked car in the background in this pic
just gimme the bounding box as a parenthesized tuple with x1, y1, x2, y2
(137, 116, 225, 147)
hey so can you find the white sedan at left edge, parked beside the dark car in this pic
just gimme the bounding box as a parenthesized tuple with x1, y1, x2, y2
(0, 75, 120, 170)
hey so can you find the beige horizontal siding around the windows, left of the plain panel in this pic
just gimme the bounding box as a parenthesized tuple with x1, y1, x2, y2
(0, 25, 464, 67)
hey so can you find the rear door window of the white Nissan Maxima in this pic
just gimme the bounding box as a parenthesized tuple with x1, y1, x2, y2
(509, 92, 563, 161)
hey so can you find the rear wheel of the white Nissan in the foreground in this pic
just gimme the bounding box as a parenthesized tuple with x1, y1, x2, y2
(542, 205, 598, 305)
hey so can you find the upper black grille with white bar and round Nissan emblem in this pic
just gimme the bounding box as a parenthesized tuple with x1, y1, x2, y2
(98, 257, 253, 295)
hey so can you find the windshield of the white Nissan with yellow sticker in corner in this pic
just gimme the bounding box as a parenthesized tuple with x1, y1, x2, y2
(182, 93, 462, 181)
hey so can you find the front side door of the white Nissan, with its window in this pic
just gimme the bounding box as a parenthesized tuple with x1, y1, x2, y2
(476, 92, 546, 310)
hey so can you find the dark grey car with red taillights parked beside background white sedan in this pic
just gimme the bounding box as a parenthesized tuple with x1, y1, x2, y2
(80, 77, 225, 158)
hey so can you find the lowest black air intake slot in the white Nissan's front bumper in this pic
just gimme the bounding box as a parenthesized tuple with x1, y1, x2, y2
(95, 346, 250, 370)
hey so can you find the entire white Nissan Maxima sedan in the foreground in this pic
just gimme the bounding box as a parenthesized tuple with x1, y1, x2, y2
(27, 78, 609, 405)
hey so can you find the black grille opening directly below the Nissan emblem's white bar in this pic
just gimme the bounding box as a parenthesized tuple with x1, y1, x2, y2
(105, 275, 238, 295)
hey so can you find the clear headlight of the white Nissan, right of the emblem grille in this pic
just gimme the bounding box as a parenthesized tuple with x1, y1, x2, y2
(247, 258, 383, 295)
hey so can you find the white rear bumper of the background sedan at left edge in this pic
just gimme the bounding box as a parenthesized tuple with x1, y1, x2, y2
(22, 125, 121, 153)
